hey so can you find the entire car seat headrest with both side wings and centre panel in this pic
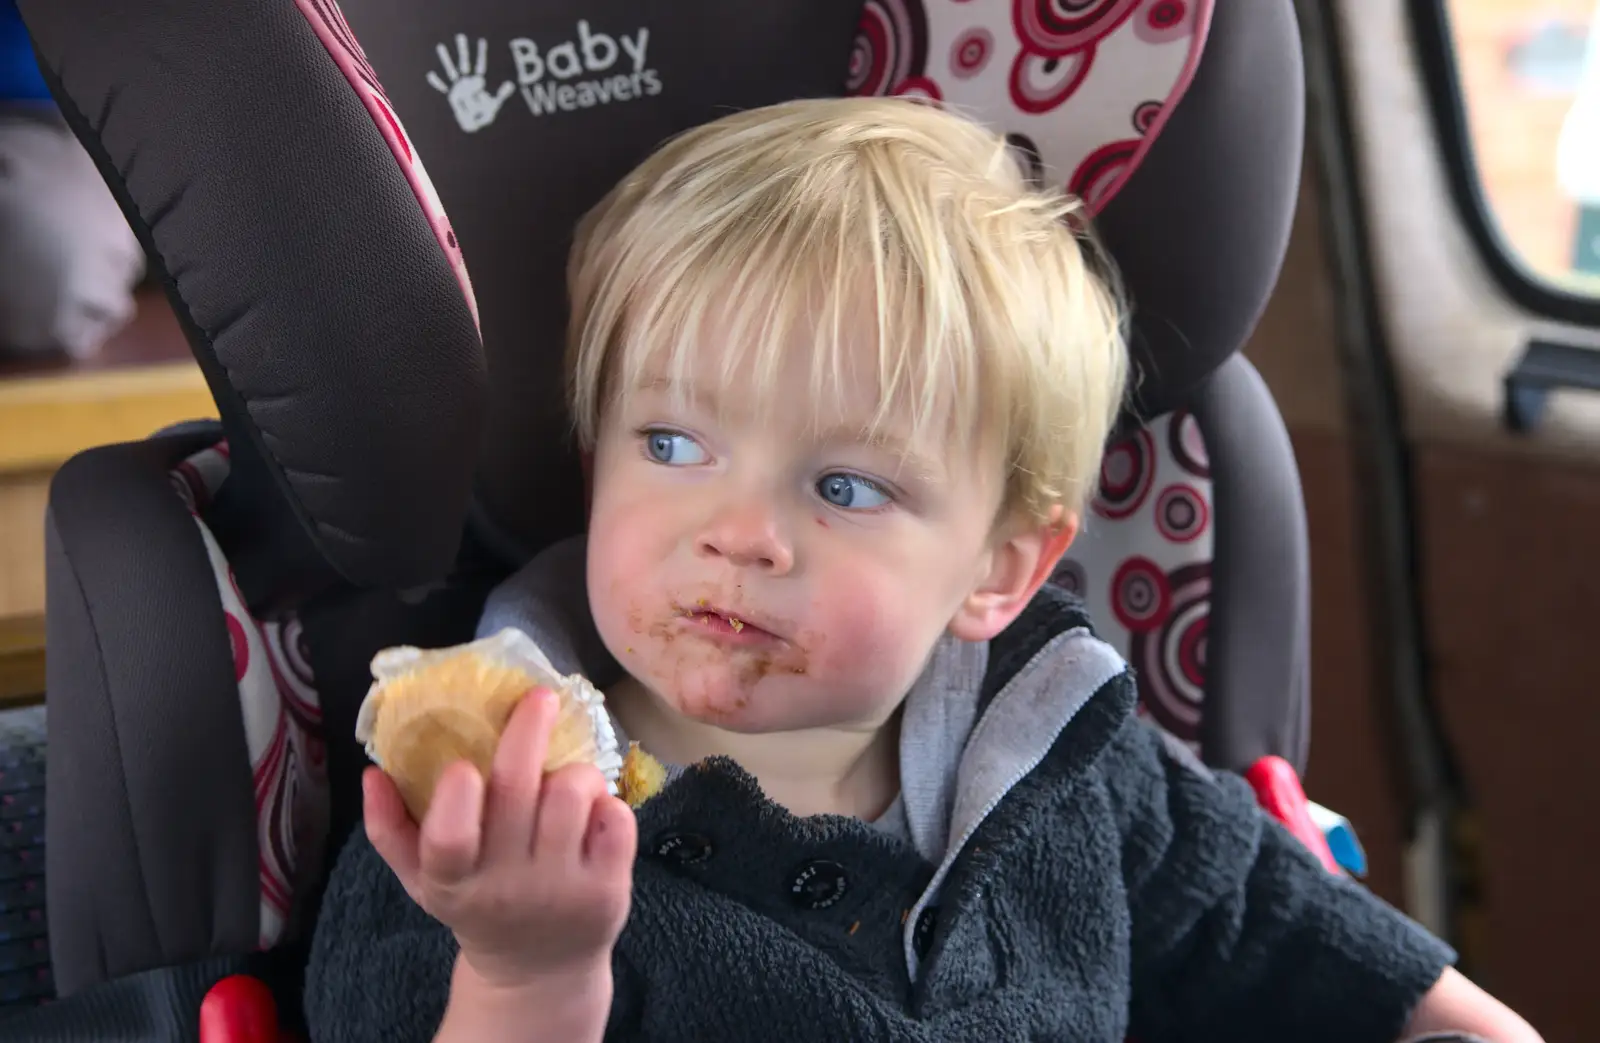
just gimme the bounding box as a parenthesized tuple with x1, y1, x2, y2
(22, 0, 1302, 584)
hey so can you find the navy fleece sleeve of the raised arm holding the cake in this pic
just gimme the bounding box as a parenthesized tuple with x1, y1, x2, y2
(306, 827, 456, 1043)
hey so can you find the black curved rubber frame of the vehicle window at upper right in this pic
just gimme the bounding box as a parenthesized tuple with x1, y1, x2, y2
(1406, 0, 1600, 326)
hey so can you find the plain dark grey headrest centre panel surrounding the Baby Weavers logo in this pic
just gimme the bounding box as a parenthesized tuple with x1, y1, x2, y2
(321, 0, 862, 563)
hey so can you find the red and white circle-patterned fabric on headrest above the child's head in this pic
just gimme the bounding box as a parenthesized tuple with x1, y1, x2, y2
(851, 0, 1214, 211)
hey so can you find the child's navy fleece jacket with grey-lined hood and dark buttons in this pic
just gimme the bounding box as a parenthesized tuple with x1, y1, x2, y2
(306, 544, 1453, 1043)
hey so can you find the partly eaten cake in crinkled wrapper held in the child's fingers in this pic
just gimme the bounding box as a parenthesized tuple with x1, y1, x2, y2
(355, 629, 622, 822)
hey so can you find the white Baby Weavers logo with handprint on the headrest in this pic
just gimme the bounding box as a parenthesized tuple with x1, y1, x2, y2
(427, 21, 661, 134)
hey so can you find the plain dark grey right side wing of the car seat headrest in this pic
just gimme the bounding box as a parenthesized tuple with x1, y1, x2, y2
(1098, 0, 1306, 418)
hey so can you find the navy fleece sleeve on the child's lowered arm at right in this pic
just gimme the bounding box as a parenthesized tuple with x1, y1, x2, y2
(1107, 721, 1454, 1043)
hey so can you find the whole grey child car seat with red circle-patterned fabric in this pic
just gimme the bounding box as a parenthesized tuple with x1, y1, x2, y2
(0, 0, 1320, 1040)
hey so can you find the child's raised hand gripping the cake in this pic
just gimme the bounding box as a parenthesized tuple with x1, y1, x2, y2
(363, 689, 637, 987)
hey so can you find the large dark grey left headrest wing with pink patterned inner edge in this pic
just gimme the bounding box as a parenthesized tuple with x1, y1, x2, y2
(19, 0, 486, 598)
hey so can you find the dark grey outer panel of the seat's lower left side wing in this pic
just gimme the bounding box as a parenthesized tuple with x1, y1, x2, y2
(45, 430, 259, 995)
